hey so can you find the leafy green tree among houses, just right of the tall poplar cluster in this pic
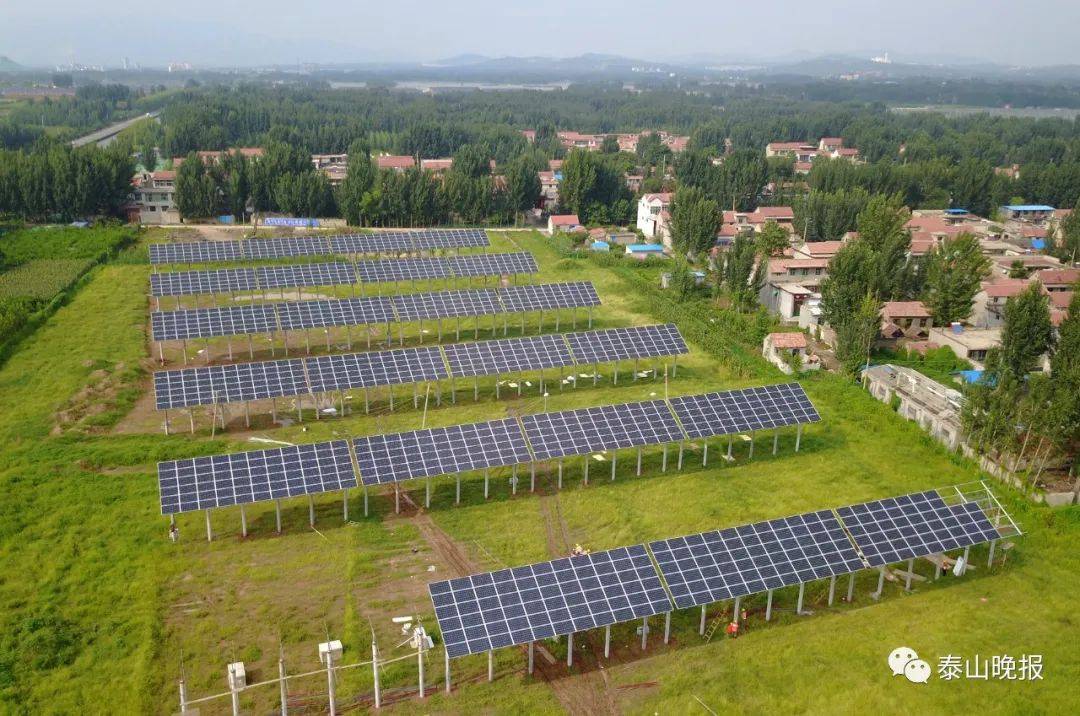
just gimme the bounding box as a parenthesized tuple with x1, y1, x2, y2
(923, 232, 990, 326)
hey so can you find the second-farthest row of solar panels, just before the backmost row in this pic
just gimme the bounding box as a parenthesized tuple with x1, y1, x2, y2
(150, 252, 539, 298)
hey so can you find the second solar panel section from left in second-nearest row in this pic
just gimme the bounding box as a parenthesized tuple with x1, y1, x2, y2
(352, 419, 531, 485)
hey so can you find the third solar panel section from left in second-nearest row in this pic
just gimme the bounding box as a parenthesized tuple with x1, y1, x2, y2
(522, 401, 684, 460)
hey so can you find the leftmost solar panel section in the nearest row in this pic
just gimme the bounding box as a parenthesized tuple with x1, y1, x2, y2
(428, 544, 672, 657)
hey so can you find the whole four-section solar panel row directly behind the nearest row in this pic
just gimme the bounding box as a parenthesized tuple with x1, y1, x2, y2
(158, 383, 821, 514)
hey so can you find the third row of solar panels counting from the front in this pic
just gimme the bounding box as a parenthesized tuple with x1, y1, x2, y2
(153, 324, 688, 410)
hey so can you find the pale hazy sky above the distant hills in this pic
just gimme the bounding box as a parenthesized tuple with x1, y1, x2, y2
(6, 0, 1080, 66)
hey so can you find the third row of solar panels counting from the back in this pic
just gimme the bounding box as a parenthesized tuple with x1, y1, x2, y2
(150, 281, 600, 341)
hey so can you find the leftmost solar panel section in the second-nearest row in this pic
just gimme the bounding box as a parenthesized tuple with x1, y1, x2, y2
(158, 440, 356, 515)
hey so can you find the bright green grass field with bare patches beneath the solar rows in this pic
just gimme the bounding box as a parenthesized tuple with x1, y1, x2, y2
(0, 232, 1080, 714)
